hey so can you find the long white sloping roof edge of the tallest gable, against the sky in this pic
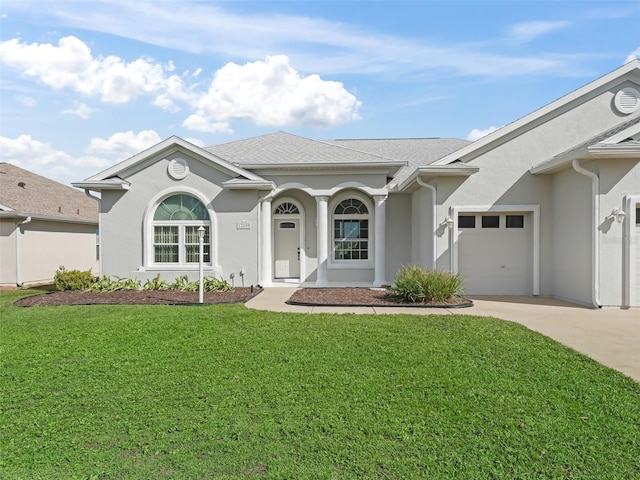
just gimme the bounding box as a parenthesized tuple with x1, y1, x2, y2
(434, 59, 640, 165)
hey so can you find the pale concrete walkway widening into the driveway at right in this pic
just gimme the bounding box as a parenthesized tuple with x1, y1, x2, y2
(247, 287, 640, 382)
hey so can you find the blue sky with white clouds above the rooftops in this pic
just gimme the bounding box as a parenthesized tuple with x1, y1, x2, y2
(0, 0, 640, 183)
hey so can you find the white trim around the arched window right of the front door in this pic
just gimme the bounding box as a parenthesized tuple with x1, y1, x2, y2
(327, 190, 375, 269)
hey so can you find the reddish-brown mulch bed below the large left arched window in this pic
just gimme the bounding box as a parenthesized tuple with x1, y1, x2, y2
(15, 287, 262, 307)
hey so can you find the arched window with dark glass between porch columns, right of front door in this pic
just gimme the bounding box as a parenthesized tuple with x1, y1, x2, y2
(333, 198, 369, 261)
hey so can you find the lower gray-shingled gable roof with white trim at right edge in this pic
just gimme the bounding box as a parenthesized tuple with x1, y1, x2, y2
(530, 114, 640, 174)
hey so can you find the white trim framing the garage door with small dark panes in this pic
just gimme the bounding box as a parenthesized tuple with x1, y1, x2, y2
(449, 205, 540, 296)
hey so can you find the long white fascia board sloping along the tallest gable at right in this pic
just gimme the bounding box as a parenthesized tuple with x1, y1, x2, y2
(431, 60, 640, 165)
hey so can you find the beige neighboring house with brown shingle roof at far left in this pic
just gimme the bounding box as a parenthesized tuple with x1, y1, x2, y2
(0, 163, 98, 287)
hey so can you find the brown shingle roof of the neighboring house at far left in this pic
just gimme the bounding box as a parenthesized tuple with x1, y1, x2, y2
(0, 163, 98, 224)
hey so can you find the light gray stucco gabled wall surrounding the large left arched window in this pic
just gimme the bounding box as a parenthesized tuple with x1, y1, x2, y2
(101, 153, 259, 286)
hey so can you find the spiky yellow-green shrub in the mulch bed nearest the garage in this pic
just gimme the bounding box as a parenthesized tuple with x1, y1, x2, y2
(391, 265, 463, 303)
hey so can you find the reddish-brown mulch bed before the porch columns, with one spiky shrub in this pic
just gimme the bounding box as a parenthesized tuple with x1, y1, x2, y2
(287, 287, 473, 308)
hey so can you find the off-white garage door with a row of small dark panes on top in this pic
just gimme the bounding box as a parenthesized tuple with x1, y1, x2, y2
(458, 212, 533, 295)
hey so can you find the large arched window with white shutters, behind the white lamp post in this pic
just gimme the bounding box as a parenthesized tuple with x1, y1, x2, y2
(153, 194, 211, 265)
